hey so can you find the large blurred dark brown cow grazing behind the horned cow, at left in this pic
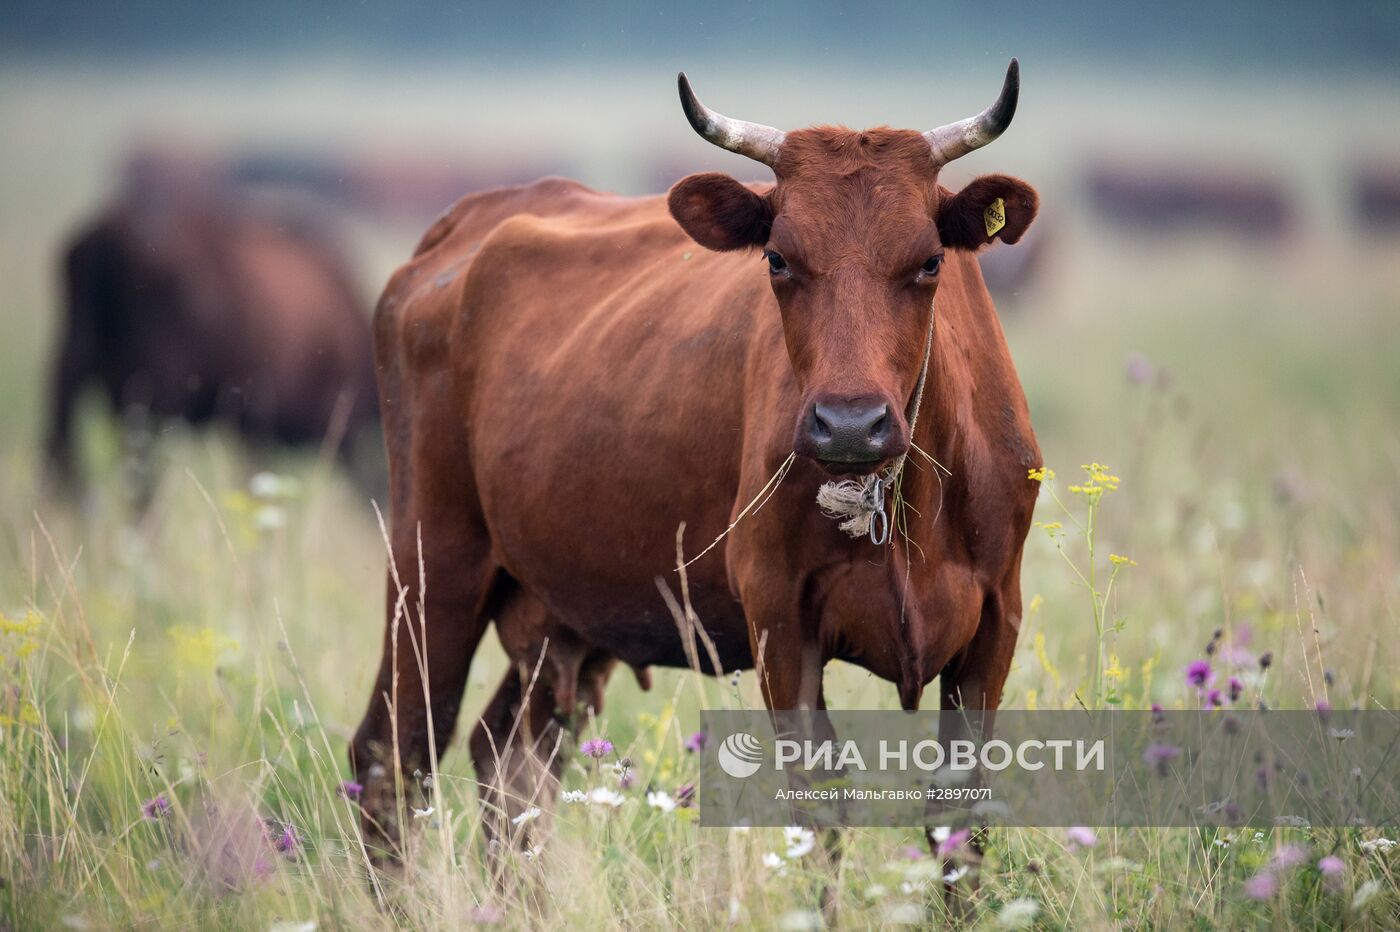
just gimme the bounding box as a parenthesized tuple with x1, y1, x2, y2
(46, 153, 378, 487)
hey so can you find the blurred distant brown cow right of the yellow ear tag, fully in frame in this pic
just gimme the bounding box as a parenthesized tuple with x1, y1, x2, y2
(1085, 162, 1295, 239)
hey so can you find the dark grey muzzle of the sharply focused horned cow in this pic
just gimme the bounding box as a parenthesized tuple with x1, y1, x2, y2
(794, 397, 907, 476)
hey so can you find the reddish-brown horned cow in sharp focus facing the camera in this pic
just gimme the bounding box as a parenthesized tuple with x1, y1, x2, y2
(351, 62, 1040, 862)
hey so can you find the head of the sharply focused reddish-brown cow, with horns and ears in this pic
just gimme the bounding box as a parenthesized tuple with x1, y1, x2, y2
(669, 60, 1037, 473)
